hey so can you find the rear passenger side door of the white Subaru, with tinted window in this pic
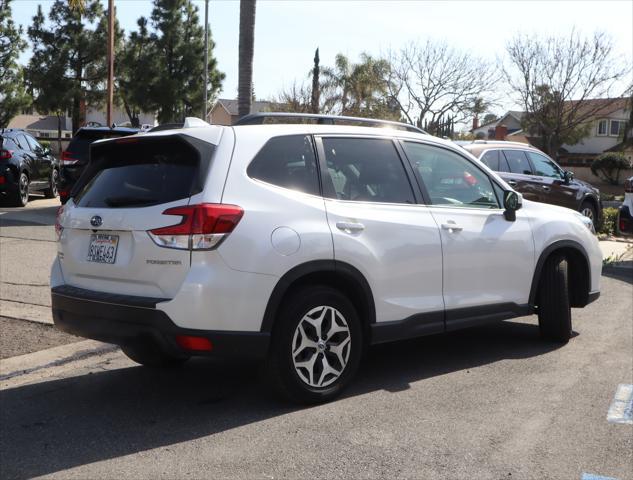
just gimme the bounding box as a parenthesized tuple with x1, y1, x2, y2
(317, 136, 444, 334)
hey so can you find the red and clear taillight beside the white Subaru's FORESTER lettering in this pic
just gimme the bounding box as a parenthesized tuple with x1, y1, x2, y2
(147, 203, 244, 250)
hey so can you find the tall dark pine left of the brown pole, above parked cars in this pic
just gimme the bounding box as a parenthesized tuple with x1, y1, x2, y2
(27, 0, 107, 131)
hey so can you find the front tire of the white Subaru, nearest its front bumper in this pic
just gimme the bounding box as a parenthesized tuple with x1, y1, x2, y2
(538, 254, 571, 344)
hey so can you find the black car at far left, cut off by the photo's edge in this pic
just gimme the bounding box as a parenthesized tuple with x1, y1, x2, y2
(0, 128, 59, 207)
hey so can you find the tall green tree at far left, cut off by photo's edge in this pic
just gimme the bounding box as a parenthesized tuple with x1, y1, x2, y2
(0, 0, 30, 127)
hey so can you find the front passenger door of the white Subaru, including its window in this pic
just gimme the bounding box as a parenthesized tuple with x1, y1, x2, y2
(402, 141, 534, 329)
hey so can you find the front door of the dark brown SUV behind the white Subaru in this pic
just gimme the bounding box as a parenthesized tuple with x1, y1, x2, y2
(526, 152, 578, 210)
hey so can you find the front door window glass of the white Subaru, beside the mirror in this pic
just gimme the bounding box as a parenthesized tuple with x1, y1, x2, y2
(404, 142, 499, 208)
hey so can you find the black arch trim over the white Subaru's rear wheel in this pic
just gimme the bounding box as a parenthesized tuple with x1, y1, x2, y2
(260, 260, 376, 332)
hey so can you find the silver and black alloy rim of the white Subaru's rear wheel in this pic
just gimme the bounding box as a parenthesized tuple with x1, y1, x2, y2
(292, 305, 352, 388)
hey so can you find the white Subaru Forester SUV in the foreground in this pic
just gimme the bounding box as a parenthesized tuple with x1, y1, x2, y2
(51, 114, 602, 402)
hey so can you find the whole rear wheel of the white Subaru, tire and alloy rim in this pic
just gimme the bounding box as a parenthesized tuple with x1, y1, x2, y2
(267, 286, 363, 403)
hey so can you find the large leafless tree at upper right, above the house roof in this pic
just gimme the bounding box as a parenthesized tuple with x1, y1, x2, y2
(503, 30, 631, 155)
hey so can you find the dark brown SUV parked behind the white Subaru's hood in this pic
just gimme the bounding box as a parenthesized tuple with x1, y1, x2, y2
(462, 140, 602, 230)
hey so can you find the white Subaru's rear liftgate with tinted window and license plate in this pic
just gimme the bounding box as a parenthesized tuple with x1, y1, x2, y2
(58, 135, 212, 298)
